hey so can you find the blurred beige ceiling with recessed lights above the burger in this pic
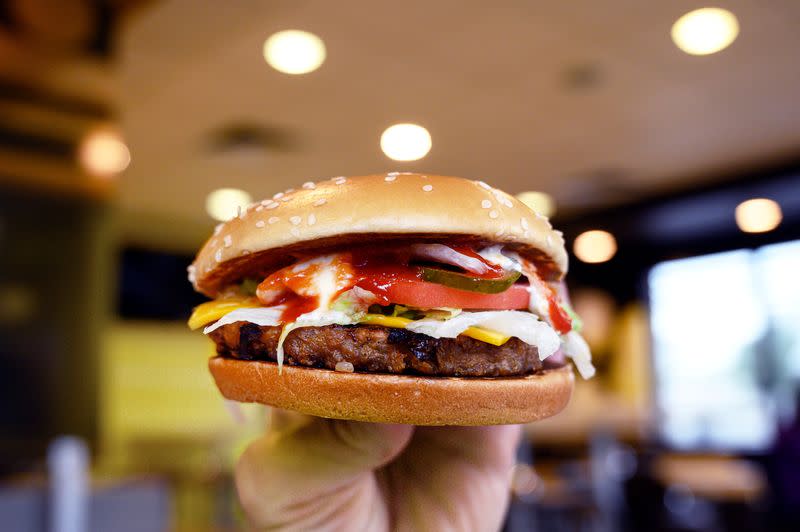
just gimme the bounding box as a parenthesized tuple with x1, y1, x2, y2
(116, 0, 800, 245)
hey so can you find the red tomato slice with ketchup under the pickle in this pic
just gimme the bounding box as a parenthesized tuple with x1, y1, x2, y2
(356, 268, 530, 310)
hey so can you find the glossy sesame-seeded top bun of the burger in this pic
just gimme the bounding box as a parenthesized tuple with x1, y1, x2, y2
(189, 176, 567, 297)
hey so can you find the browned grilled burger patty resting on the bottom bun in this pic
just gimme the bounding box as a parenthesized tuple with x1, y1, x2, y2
(209, 322, 552, 377)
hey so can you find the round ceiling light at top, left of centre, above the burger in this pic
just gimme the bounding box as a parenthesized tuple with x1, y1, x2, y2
(263, 30, 326, 74)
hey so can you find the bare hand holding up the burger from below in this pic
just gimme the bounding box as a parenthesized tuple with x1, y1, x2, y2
(236, 411, 520, 531)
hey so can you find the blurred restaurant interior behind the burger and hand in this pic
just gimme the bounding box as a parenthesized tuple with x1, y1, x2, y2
(0, 0, 800, 531)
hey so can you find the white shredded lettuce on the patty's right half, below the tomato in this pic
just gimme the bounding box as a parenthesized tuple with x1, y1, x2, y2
(406, 310, 561, 360)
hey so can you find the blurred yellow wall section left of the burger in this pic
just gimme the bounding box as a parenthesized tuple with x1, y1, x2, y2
(98, 321, 264, 474)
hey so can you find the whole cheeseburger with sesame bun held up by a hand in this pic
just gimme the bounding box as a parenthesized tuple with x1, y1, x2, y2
(189, 177, 594, 425)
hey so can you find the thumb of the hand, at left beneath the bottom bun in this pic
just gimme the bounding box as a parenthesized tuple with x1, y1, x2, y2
(235, 411, 414, 528)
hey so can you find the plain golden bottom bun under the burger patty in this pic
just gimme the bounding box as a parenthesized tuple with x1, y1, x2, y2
(208, 357, 574, 425)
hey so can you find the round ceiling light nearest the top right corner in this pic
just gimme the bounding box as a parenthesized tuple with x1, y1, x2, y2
(672, 7, 739, 55)
